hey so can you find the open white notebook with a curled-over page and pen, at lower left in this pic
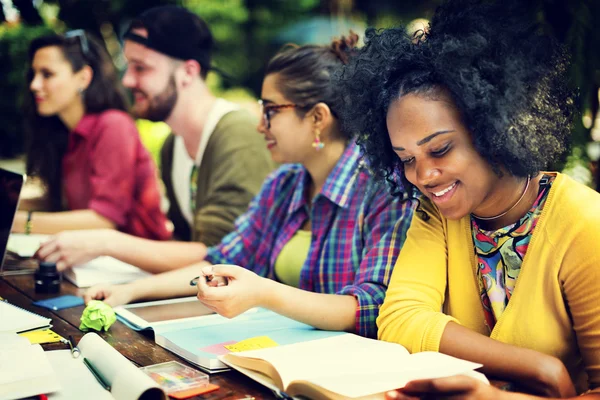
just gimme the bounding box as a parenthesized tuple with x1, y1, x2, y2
(46, 333, 167, 400)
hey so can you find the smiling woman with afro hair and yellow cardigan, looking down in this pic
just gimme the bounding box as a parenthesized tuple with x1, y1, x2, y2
(338, 1, 600, 399)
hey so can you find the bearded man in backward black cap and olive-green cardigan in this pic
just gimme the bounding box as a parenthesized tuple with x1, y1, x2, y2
(37, 6, 275, 273)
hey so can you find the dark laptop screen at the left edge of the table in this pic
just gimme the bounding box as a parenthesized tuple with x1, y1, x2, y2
(0, 168, 25, 270)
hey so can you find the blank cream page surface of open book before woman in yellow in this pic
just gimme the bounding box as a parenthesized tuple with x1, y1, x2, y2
(227, 334, 481, 397)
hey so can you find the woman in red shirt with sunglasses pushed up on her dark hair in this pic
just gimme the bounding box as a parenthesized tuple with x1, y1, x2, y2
(13, 30, 170, 240)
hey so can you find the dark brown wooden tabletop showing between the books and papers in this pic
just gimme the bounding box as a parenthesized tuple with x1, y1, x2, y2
(0, 275, 276, 400)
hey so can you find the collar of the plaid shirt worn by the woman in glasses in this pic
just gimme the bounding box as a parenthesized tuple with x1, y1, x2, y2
(289, 143, 363, 213)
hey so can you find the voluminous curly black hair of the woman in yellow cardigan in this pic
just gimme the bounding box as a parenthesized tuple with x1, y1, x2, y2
(335, 0, 574, 194)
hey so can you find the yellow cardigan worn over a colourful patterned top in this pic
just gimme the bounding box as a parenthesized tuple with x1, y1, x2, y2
(377, 174, 600, 393)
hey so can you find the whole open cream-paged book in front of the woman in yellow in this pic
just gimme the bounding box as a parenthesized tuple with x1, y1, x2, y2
(219, 333, 487, 400)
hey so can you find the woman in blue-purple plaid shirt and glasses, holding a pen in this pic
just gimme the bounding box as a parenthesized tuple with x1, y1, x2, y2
(68, 35, 413, 337)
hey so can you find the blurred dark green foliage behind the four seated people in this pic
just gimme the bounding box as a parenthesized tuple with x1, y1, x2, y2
(0, 0, 600, 187)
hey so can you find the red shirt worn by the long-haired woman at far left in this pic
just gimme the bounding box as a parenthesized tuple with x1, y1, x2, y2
(62, 110, 171, 240)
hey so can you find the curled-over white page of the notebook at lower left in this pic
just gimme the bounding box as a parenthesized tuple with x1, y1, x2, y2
(77, 333, 167, 400)
